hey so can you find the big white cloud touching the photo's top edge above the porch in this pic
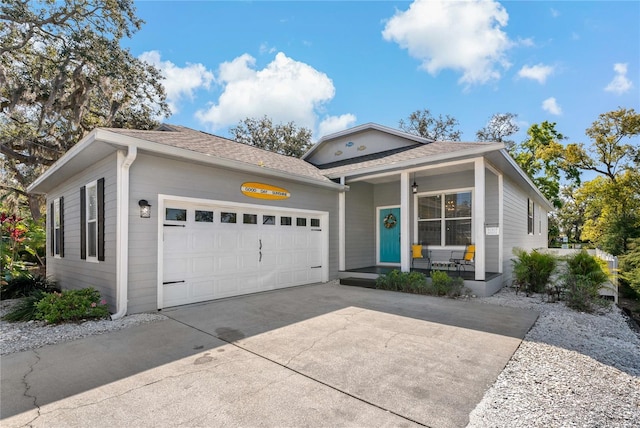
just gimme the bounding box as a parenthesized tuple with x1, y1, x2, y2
(382, 0, 513, 85)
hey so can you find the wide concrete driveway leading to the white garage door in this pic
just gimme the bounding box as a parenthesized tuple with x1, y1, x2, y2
(0, 284, 538, 427)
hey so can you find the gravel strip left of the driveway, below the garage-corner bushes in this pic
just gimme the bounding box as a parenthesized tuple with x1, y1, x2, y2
(0, 299, 167, 355)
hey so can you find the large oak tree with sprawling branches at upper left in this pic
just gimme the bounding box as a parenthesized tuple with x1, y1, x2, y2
(0, 0, 169, 219)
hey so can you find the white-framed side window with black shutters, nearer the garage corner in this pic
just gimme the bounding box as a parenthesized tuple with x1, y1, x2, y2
(80, 178, 105, 261)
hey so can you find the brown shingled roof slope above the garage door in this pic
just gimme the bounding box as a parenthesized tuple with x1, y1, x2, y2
(106, 125, 330, 182)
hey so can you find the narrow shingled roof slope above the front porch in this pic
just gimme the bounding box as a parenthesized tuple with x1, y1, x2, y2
(322, 141, 503, 178)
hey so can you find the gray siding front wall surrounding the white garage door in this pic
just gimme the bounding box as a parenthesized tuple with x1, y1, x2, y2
(129, 154, 338, 313)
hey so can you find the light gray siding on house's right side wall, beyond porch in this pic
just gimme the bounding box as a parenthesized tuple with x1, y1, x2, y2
(503, 177, 548, 285)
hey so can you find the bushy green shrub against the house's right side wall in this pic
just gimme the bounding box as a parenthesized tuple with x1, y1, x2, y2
(513, 248, 557, 295)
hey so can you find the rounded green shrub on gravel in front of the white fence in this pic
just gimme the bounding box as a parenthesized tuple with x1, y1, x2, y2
(563, 251, 609, 312)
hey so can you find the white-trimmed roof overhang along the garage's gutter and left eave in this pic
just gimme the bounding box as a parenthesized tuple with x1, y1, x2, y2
(27, 128, 348, 194)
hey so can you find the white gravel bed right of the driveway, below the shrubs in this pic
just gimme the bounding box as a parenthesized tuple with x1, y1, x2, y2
(468, 289, 640, 427)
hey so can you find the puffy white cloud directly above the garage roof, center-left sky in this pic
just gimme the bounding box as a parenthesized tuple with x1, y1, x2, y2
(196, 52, 344, 135)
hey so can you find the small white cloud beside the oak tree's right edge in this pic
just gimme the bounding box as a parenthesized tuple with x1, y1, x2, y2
(139, 51, 214, 113)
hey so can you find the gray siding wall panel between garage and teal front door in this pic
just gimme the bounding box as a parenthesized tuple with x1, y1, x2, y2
(345, 183, 376, 269)
